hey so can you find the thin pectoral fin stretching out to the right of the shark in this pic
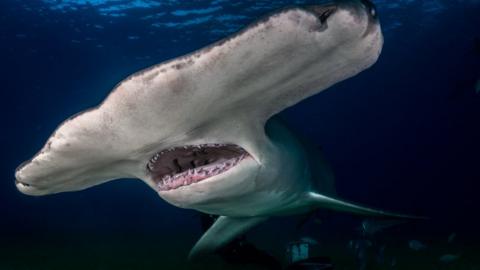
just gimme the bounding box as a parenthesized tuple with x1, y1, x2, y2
(307, 192, 427, 219)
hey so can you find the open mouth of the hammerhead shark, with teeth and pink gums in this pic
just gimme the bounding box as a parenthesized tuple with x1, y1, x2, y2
(147, 144, 249, 191)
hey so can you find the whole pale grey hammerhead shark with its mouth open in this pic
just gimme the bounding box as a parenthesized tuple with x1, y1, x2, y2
(15, 0, 414, 257)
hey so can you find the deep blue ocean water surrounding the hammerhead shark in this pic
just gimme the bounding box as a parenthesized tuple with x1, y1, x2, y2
(0, 0, 480, 270)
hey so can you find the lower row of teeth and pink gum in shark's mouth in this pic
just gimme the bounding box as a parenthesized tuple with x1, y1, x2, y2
(157, 154, 247, 191)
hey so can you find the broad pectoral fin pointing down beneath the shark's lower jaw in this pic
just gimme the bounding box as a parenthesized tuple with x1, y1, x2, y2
(189, 216, 268, 259)
